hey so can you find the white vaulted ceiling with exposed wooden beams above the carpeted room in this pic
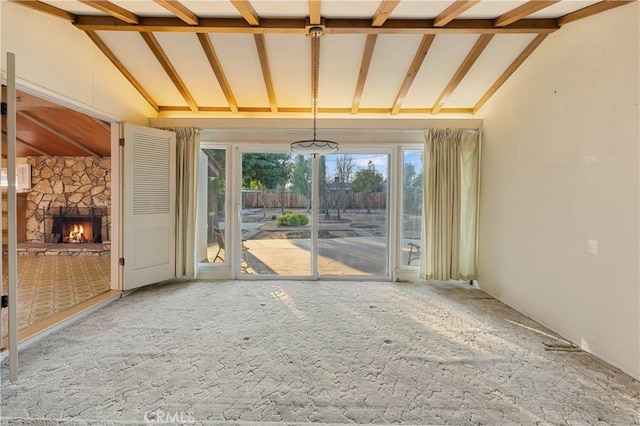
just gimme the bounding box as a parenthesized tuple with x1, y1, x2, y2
(12, 0, 630, 120)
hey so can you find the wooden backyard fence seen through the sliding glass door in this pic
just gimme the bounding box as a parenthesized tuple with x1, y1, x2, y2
(242, 191, 387, 210)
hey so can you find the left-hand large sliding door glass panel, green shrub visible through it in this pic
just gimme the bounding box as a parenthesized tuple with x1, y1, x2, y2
(240, 152, 312, 276)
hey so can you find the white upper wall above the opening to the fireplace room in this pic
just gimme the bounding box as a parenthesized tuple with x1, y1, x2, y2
(0, 1, 156, 125)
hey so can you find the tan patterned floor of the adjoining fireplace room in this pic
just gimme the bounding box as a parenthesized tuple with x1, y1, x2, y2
(2, 256, 110, 336)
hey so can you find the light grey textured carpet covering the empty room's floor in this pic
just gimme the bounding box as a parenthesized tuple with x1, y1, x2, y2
(0, 281, 640, 425)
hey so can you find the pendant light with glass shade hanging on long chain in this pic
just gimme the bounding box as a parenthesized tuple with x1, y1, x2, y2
(291, 27, 339, 157)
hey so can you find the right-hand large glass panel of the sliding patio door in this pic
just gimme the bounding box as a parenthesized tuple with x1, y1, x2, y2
(318, 153, 389, 276)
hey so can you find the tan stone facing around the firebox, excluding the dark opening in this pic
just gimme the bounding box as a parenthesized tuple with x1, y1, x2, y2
(26, 157, 111, 243)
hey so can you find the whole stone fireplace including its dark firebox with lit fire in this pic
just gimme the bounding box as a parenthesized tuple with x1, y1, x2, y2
(26, 157, 111, 244)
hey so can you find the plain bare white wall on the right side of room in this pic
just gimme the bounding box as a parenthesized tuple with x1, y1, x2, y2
(478, 3, 640, 378)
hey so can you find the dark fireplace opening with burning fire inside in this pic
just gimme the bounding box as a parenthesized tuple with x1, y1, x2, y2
(51, 207, 103, 244)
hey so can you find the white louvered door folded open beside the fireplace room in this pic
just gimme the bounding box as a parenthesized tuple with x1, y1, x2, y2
(122, 124, 176, 290)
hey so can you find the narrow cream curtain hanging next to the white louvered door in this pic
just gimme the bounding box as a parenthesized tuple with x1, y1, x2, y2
(170, 128, 200, 278)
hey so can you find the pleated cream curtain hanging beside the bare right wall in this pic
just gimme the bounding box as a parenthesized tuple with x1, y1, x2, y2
(420, 129, 479, 280)
